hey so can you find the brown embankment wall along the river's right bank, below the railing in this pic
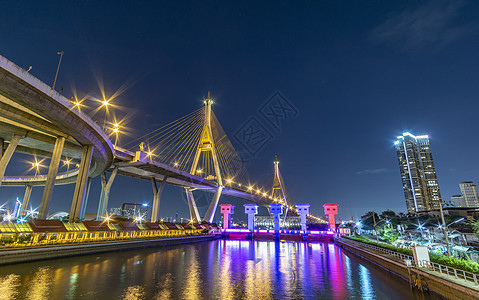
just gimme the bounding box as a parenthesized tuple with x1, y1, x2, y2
(335, 238, 479, 300)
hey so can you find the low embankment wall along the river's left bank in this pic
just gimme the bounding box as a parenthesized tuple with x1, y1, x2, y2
(0, 234, 221, 265)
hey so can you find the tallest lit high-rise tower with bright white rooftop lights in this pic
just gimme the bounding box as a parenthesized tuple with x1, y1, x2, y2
(394, 132, 442, 214)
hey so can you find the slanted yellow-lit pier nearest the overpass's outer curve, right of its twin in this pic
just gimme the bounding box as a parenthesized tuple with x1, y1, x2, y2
(68, 145, 93, 222)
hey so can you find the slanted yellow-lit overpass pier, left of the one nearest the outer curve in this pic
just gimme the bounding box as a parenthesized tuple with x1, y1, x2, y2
(38, 136, 65, 219)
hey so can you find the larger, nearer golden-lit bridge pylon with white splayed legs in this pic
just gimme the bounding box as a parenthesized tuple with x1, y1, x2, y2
(185, 92, 223, 223)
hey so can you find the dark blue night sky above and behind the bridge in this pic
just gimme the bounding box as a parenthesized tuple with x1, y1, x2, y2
(0, 1, 479, 218)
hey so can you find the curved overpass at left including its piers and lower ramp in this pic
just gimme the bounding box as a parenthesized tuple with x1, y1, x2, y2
(0, 56, 114, 220)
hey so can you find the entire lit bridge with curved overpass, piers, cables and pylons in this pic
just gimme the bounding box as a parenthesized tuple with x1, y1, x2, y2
(0, 56, 321, 222)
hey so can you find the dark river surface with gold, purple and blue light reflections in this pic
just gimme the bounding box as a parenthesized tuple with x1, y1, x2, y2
(0, 240, 442, 300)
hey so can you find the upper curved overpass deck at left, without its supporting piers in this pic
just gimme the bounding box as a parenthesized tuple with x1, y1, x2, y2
(0, 56, 113, 177)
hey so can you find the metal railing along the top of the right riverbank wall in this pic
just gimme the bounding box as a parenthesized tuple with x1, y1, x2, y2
(347, 239, 479, 285)
